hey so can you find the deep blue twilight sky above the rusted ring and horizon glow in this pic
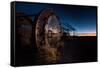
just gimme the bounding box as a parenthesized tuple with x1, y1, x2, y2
(16, 2, 97, 33)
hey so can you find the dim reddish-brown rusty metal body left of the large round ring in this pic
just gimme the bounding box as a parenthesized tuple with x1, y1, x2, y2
(16, 13, 32, 48)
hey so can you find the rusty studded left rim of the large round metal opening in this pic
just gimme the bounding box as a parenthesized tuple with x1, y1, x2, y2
(35, 10, 53, 47)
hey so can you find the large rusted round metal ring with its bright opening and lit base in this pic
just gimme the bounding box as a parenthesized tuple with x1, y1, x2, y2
(35, 9, 61, 63)
